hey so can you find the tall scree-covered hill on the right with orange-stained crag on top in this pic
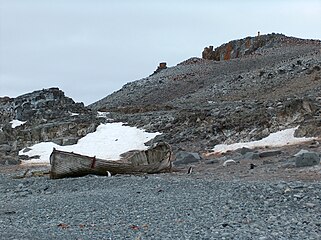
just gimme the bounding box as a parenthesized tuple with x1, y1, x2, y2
(89, 34, 321, 151)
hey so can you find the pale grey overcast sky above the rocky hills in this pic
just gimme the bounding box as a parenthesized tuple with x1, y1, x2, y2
(0, 0, 321, 104)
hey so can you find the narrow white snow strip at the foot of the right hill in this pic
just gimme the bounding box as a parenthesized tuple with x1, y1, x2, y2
(213, 127, 315, 153)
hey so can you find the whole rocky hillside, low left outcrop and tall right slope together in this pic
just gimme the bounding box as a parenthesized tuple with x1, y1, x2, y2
(0, 34, 321, 164)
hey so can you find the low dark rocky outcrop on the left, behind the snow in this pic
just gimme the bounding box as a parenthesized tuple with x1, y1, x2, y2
(0, 88, 101, 164)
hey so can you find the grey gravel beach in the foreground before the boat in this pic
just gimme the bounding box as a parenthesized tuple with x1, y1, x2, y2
(0, 170, 321, 240)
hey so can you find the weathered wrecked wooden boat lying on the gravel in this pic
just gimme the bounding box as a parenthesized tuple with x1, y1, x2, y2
(50, 142, 172, 179)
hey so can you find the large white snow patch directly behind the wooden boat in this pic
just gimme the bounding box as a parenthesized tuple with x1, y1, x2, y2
(19, 123, 160, 164)
